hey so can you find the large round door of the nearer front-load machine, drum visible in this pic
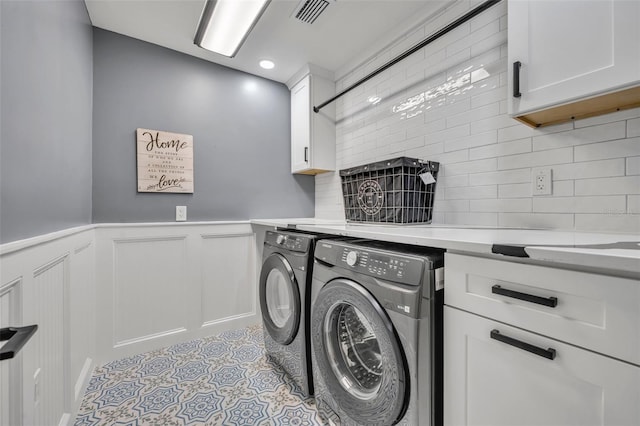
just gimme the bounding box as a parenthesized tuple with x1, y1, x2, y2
(311, 279, 410, 425)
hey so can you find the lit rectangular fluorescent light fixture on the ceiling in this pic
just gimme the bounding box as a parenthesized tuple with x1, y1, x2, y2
(193, 0, 271, 58)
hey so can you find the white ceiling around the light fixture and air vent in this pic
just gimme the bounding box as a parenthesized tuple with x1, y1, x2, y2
(85, 0, 448, 83)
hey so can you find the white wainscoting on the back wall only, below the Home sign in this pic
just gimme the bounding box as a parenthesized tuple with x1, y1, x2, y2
(96, 222, 260, 364)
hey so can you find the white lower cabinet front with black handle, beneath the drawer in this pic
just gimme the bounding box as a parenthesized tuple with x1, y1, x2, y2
(444, 306, 640, 426)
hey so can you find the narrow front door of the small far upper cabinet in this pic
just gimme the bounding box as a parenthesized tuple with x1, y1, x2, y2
(291, 75, 311, 173)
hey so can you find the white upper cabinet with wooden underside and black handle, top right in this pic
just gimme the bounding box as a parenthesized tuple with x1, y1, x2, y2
(508, 0, 640, 126)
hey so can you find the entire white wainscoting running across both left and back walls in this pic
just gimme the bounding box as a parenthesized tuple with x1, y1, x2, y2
(0, 222, 261, 426)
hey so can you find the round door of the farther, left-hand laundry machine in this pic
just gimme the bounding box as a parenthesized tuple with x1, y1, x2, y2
(259, 253, 300, 345)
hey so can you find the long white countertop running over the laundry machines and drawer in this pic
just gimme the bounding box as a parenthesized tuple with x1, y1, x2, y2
(251, 218, 640, 277)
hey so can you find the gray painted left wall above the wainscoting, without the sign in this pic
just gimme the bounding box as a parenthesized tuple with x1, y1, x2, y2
(0, 0, 93, 243)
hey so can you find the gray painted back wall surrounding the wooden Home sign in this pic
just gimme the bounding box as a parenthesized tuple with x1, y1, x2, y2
(93, 28, 314, 223)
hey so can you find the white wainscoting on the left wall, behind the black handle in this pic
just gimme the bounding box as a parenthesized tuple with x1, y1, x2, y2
(0, 227, 97, 426)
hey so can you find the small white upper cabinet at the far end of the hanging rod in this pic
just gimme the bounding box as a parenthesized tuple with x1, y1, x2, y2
(290, 65, 336, 175)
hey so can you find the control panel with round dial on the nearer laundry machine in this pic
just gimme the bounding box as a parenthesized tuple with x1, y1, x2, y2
(337, 247, 424, 285)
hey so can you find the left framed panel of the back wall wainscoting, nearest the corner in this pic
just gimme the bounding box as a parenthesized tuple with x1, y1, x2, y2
(113, 235, 191, 346)
